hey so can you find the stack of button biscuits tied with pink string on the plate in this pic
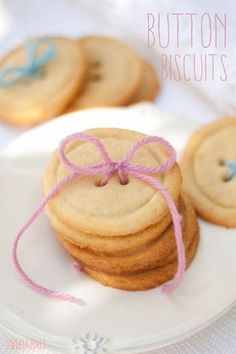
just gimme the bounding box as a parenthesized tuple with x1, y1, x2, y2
(44, 128, 199, 290)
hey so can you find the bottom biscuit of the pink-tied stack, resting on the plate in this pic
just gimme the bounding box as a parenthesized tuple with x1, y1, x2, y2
(82, 232, 199, 291)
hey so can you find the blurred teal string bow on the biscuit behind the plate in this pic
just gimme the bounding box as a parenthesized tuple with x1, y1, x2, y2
(0, 38, 56, 87)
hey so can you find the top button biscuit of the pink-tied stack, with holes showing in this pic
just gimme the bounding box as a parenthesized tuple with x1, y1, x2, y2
(44, 128, 181, 236)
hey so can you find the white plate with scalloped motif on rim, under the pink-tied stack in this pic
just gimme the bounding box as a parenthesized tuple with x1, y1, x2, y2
(0, 104, 236, 353)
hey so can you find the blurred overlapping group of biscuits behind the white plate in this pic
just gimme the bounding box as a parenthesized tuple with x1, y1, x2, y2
(0, 36, 159, 125)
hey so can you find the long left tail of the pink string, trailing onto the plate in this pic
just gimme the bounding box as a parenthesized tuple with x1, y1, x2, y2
(12, 174, 85, 305)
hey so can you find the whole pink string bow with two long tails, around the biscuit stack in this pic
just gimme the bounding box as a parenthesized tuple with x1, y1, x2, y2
(13, 133, 185, 304)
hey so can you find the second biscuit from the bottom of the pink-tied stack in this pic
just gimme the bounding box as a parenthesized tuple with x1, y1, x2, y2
(58, 197, 197, 275)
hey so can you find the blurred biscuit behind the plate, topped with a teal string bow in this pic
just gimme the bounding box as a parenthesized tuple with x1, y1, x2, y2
(0, 37, 88, 125)
